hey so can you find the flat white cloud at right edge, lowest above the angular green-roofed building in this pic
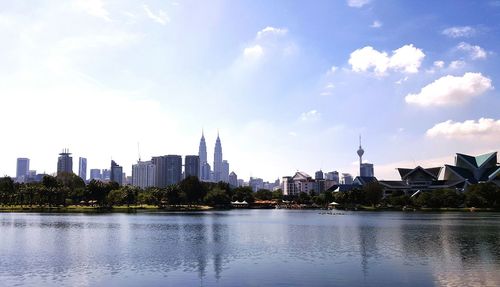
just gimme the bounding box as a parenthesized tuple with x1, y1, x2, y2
(426, 118, 500, 140)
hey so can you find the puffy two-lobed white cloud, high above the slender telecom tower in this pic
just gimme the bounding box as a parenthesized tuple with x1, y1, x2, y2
(349, 44, 425, 76)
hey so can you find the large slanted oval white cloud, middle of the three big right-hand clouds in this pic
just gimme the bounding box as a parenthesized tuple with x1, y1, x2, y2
(405, 73, 493, 107)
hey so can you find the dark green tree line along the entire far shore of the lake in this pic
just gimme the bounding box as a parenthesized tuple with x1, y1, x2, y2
(0, 173, 500, 208)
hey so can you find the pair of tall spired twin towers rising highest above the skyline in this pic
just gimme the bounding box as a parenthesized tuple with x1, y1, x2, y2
(198, 131, 229, 182)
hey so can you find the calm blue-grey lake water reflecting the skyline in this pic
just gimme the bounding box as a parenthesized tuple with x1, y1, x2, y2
(0, 210, 500, 286)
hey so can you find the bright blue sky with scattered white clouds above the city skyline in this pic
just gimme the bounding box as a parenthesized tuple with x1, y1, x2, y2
(0, 0, 500, 181)
